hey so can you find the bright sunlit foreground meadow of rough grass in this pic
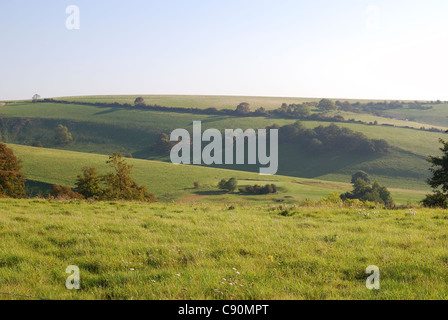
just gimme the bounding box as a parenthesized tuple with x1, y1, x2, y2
(0, 200, 448, 300)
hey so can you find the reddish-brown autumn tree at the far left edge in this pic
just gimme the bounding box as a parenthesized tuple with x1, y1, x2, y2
(0, 143, 25, 198)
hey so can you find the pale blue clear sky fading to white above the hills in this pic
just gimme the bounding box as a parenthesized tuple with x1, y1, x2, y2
(0, 0, 448, 100)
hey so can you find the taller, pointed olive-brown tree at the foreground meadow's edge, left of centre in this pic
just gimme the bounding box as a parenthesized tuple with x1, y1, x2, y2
(102, 152, 155, 202)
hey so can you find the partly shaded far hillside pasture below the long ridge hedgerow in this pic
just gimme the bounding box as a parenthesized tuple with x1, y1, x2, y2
(0, 103, 444, 190)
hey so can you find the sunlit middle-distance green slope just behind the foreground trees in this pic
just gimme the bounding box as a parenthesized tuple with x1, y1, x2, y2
(9, 145, 426, 204)
